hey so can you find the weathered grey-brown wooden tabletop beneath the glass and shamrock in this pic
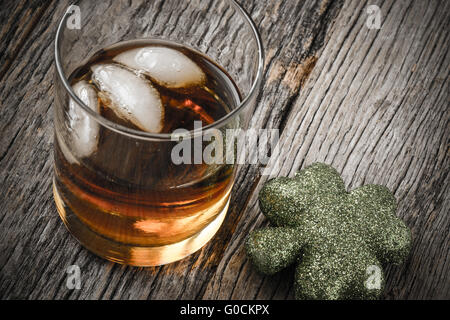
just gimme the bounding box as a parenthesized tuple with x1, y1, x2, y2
(0, 0, 450, 299)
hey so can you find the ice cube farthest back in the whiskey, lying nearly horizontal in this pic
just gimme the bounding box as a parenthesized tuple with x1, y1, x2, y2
(114, 47, 205, 88)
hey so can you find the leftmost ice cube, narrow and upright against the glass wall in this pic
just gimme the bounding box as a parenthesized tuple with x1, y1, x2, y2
(68, 81, 100, 158)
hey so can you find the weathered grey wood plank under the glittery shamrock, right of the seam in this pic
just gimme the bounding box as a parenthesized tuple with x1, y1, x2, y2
(204, 1, 450, 299)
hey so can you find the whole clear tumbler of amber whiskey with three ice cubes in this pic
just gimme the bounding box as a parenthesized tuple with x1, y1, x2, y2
(53, 0, 264, 266)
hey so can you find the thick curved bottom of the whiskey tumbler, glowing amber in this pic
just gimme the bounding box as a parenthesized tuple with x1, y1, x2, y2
(53, 182, 230, 267)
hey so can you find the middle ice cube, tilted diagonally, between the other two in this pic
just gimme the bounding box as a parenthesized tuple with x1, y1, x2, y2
(91, 64, 164, 133)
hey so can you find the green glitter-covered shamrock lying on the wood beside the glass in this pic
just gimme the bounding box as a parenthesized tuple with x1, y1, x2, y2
(245, 163, 411, 299)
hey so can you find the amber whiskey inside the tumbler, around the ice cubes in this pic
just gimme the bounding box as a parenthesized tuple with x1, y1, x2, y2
(55, 41, 240, 265)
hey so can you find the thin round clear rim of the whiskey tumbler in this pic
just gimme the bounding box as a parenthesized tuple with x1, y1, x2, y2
(55, 0, 264, 141)
